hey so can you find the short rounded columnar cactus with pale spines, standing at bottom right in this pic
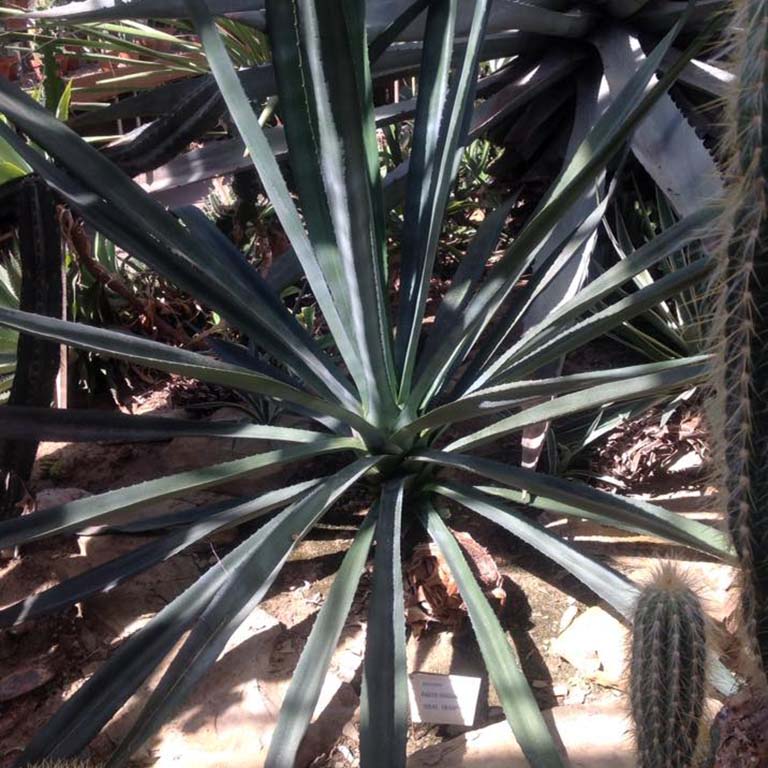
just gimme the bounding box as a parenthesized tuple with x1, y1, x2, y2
(629, 566, 707, 768)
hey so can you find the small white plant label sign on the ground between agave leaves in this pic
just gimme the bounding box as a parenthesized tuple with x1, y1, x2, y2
(408, 672, 480, 725)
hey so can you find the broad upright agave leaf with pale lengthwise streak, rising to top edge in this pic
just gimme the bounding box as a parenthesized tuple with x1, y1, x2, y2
(270, 0, 395, 424)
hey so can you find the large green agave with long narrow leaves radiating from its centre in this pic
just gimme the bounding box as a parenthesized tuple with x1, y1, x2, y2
(0, 0, 733, 768)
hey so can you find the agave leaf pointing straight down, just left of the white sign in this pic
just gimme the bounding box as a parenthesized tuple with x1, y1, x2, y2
(360, 479, 408, 768)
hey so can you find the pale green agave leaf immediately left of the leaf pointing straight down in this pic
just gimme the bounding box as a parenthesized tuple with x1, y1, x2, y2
(265, 512, 376, 768)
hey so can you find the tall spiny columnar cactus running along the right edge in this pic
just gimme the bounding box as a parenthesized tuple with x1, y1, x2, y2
(712, 0, 768, 690)
